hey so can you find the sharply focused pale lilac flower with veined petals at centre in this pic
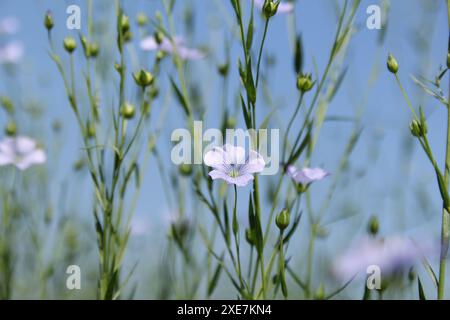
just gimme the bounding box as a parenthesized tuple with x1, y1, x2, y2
(204, 144, 266, 187)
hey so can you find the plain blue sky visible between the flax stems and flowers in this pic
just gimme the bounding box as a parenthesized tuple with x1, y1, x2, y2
(0, 0, 448, 298)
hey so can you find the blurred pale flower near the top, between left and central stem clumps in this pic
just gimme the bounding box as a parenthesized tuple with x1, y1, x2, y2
(140, 36, 205, 60)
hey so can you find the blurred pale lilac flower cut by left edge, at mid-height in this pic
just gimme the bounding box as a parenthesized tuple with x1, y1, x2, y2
(0, 137, 47, 170)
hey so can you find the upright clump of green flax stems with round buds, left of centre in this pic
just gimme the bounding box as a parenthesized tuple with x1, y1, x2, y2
(44, 4, 159, 299)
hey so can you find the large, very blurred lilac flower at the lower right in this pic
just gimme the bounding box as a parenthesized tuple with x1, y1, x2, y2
(333, 236, 436, 279)
